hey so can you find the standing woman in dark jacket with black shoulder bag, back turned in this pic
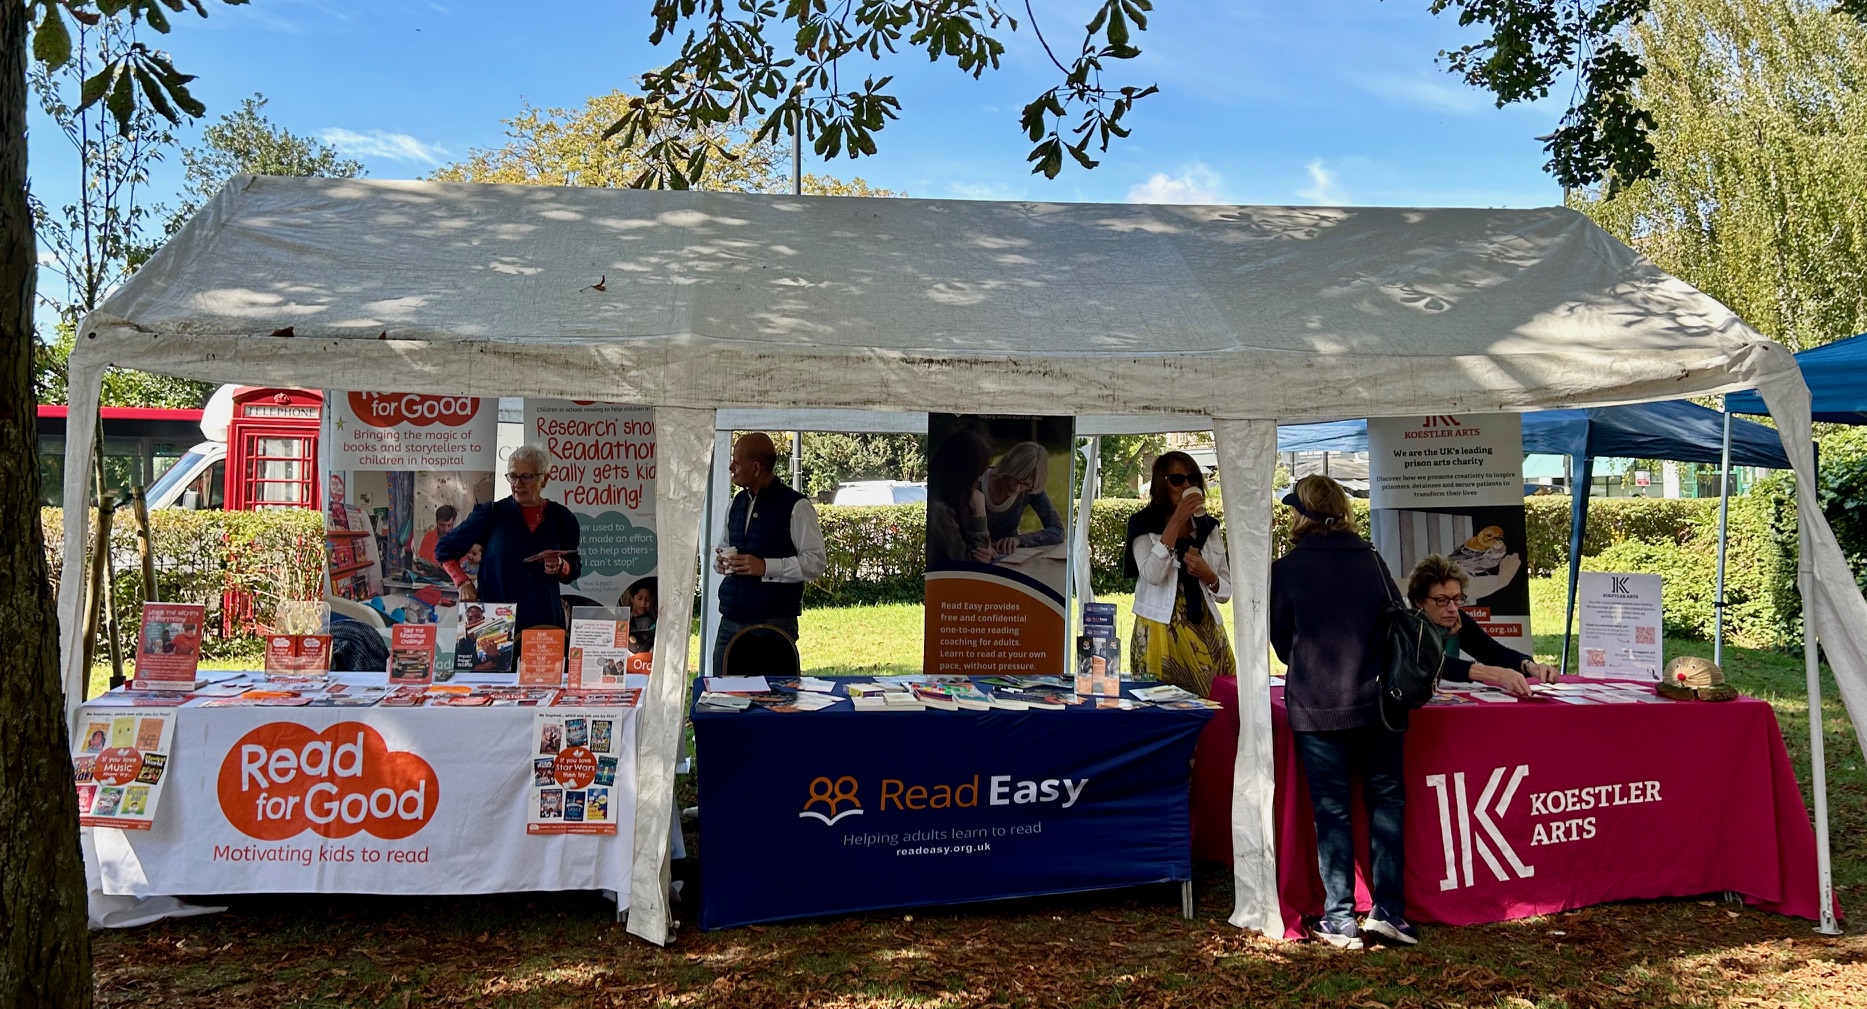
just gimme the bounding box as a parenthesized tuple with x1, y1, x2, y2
(1270, 475, 1419, 949)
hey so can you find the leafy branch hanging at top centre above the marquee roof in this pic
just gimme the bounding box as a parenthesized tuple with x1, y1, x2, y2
(619, 0, 1156, 189)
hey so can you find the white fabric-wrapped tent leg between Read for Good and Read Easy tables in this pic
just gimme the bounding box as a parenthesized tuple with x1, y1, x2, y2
(629, 407, 715, 945)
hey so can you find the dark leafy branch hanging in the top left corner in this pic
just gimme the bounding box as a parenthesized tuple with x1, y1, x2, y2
(26, 0, 246, 136)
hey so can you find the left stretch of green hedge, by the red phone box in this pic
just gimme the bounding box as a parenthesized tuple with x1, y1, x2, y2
(39, 508, 325, 658)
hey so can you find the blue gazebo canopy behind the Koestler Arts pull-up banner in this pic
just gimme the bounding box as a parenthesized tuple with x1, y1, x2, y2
(1277, 400, 1789, 469)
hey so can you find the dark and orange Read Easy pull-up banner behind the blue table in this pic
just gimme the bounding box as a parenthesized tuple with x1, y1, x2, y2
(922, 413, 1075, 675)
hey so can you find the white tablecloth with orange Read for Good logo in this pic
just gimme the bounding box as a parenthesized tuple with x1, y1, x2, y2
(86, 706, 635, 901)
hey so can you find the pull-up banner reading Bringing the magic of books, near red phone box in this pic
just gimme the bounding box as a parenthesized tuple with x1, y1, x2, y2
(323, 392, 510, 678)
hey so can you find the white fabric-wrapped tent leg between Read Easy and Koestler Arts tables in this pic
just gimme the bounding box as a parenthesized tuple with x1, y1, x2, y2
(1212, 420, 1283, 938)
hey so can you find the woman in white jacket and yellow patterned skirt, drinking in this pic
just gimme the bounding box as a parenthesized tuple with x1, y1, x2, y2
(1122, 452, 1238, 697)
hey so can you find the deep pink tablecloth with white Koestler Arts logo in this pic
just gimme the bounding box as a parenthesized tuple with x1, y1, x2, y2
(1193, 676, 1818, 936)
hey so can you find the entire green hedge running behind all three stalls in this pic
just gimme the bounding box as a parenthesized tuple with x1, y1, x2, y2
(43, 480, 1802, 656)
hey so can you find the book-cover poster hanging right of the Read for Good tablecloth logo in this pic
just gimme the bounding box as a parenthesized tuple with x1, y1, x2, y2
(525, 708, 627, 833)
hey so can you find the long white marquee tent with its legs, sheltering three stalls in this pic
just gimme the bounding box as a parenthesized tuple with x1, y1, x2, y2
(60, 178, 1867, 942)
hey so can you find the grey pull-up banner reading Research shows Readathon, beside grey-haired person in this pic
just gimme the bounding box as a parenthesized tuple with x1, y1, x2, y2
(525, 400, 655, 605)
